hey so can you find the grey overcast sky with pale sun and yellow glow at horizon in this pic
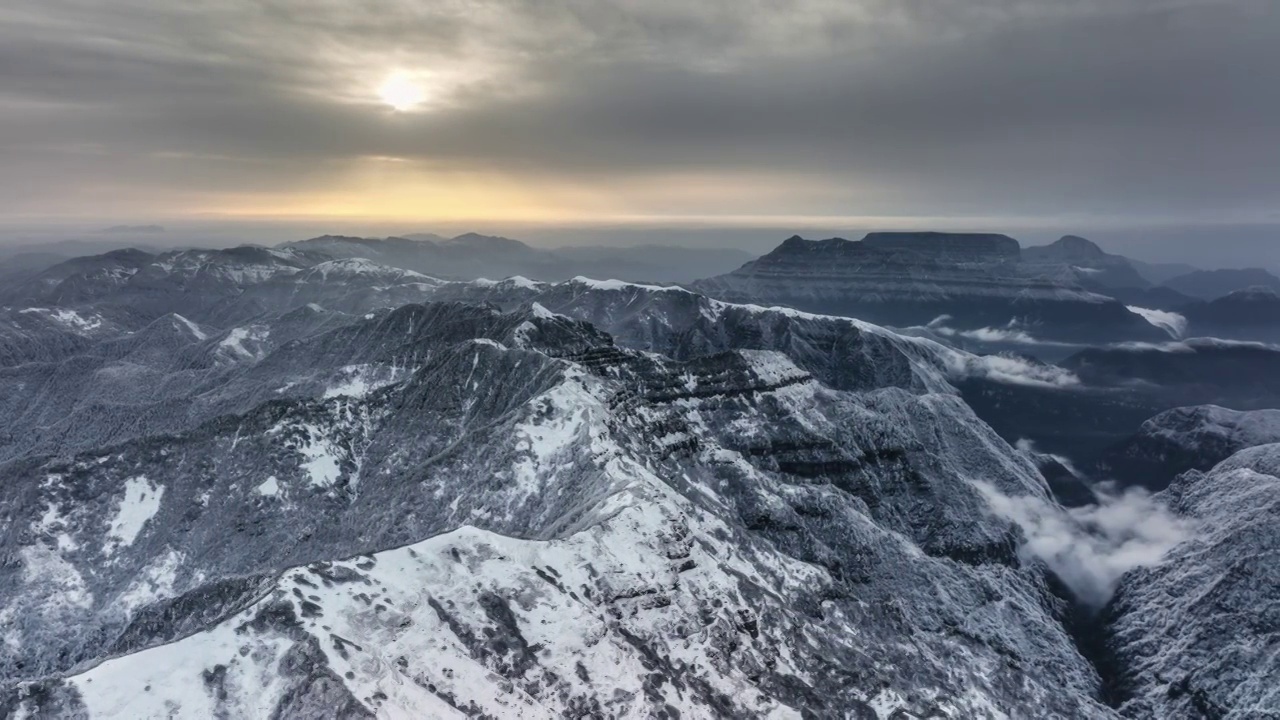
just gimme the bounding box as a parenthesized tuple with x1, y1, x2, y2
(0, 0, 1280, 260)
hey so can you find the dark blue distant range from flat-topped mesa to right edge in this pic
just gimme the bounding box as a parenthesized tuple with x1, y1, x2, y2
(691, 228, 1280, 343)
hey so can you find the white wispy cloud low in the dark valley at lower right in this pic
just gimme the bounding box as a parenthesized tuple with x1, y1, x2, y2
(974, 482, 1194, 609)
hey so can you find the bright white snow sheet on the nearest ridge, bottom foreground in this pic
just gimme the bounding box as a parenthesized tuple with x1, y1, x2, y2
(68, 488, 819, 717)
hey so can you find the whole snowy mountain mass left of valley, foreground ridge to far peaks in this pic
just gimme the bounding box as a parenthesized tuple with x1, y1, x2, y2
(0, 238, 1270, 720)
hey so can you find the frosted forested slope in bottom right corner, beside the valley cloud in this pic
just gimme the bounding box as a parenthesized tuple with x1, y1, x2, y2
(1108, 445, 1280, 720)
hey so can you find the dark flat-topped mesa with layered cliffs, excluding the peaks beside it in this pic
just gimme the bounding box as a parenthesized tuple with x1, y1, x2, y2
(695, 233, 1160, 341)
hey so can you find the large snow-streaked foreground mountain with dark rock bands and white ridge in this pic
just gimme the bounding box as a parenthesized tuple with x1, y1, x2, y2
(4, 288, 1105, 716)
